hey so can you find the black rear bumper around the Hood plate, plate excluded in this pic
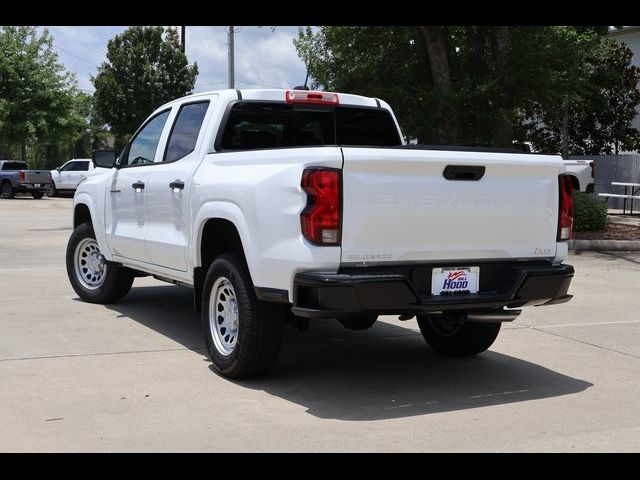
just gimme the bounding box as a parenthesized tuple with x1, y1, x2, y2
(292, 262, 574, 318)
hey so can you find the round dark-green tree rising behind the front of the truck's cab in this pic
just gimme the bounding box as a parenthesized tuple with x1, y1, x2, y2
(91, 26, 198, 135)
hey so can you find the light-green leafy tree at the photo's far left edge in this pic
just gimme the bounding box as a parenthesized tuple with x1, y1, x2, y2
(0, 27, 77, 160)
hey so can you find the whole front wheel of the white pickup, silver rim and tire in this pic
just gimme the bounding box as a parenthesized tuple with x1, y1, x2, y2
(67, 222, 134, 303)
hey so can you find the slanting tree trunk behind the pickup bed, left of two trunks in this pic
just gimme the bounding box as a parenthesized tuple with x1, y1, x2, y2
(418, 26, 459, 144)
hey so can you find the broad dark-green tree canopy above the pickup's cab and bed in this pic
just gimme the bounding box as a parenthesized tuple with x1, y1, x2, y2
(295, 26, 632, 146)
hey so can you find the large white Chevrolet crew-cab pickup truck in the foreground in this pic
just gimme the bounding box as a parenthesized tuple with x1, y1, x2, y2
(66, 90, 574, 378)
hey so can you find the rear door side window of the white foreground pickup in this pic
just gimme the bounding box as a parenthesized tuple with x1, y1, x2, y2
(163, 101, 209, 162)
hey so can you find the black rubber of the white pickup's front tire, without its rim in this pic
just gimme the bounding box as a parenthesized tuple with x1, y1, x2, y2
(67, 222, 134, 303)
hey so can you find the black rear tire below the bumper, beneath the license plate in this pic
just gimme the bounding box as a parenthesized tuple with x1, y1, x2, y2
(418, 315, 502, 357)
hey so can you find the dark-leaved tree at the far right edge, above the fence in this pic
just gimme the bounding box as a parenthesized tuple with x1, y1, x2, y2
(518, 40, 640, 155)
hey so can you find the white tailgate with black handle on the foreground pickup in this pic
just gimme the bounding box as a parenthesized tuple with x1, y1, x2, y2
(341, 147, 564, 264)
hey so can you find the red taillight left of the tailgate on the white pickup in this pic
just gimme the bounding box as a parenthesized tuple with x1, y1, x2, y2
(300, 168, 341, 245)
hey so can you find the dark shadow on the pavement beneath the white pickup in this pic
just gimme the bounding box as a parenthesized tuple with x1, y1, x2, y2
(109, 286, 593, 421)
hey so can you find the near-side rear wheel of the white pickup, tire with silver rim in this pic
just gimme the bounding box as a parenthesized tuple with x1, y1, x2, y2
(202, 253, 286, 379)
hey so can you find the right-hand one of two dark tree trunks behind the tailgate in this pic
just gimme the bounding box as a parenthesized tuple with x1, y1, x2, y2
(491, 27, 514, 147)
